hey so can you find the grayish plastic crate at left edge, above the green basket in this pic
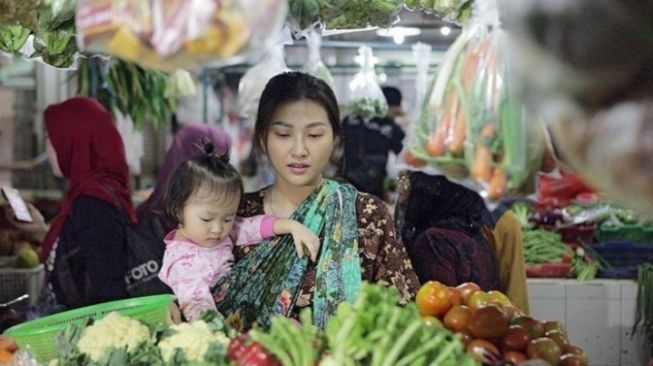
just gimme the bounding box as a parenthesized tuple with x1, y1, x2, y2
(0, 264, 45, 306)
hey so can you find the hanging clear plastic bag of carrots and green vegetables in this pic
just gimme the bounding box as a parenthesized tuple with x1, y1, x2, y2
(404, 0, 542, 200)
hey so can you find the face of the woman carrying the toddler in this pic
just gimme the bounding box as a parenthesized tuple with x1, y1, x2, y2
(265, 98, 335, 187)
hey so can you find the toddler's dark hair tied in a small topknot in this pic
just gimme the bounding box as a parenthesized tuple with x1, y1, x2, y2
(164, 142, 243, 227)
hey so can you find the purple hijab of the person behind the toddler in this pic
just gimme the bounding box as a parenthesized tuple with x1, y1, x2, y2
(137, 123, 231, 221)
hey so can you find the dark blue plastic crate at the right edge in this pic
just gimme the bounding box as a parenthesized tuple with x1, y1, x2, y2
(591, 241, 653, 278)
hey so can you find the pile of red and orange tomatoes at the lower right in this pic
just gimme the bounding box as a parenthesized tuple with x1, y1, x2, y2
(416, 281, 587, 365)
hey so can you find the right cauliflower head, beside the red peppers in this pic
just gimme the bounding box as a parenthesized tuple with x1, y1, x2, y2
(159, 321, 229, 363)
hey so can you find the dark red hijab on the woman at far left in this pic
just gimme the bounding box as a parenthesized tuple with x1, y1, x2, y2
(41, 97, 136, 260)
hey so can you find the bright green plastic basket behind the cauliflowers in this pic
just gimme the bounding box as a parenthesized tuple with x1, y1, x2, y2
(4, 294, 175, 362)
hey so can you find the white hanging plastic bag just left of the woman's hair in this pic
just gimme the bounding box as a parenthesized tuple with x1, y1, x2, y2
(238, 46, 290, 120)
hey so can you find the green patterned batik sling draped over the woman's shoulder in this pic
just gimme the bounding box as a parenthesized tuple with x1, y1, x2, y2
(213, 179, 361, 331)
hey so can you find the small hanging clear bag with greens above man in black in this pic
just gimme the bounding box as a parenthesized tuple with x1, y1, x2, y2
(347, 46, 388, 119)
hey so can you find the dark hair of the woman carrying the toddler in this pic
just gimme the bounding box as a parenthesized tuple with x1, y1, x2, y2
(254, 71, 342, 150)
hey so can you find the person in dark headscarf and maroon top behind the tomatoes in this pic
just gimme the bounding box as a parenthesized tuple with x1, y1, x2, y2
(396, 172, 500, 291)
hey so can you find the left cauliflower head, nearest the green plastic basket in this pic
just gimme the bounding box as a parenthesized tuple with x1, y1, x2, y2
(77, 312, 150, 362)
